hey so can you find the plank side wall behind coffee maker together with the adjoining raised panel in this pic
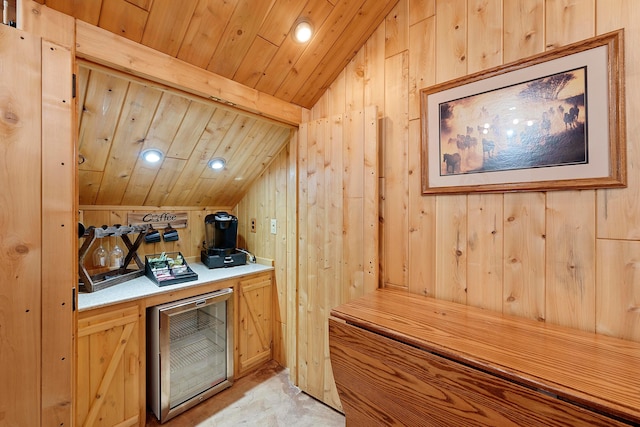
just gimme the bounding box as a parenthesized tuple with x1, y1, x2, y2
(238, 107, 378, 407)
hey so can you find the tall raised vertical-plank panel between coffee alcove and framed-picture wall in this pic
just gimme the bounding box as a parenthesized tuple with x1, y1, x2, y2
(282, 108, 378, 406)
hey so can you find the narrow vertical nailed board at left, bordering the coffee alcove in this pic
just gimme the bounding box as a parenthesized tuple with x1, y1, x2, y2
(42, 37, 78, 425)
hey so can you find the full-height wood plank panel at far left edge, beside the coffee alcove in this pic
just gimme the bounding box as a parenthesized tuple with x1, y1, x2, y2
(0, 2, 77, 425)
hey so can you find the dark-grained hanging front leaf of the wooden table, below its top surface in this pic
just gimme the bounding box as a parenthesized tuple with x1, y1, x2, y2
(329, 318, 626, 427)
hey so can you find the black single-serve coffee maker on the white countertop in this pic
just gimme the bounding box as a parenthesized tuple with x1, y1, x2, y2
(200, 212, 247, 268)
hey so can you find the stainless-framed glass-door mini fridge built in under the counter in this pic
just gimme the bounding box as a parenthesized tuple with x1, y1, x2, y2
(147, 288, 233, 423)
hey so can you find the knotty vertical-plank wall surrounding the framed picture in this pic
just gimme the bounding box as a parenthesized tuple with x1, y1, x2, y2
(240, 0, 640, 408)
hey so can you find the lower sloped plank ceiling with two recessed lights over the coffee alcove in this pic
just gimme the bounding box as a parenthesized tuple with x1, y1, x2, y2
(78, 63, 292, 207)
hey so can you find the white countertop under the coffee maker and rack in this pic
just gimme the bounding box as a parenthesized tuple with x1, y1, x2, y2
(78, 262, 273, 311)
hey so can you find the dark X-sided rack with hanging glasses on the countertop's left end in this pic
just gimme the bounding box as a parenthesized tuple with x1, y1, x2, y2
(78, 224, 149, 292)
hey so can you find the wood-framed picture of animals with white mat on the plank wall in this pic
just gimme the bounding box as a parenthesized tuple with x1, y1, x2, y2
(420, 30, 626, 194)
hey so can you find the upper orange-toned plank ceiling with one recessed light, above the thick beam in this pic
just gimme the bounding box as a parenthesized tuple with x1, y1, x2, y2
(38, 0, 398, 108)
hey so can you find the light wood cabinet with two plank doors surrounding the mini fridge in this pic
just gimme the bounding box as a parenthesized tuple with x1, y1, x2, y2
(76, 271, 274, 427)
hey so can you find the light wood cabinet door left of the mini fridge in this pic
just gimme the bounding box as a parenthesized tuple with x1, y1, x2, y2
(76, 305, 144, 426)
